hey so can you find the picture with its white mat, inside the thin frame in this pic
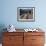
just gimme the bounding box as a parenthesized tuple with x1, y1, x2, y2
(18, 7, 34, 21)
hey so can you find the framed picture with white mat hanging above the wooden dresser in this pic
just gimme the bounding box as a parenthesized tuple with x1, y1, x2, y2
(17, 7, 35, 22)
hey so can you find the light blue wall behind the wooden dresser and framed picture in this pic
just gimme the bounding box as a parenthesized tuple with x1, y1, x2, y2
(0, 0, 46, 28)
